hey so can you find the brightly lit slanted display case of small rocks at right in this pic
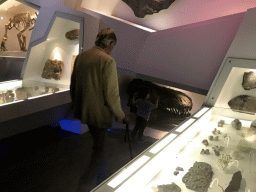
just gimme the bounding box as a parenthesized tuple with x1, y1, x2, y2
(92, 58, 256, 192)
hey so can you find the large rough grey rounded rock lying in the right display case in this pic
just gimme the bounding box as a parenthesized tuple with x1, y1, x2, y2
(182, 162, 213, 192)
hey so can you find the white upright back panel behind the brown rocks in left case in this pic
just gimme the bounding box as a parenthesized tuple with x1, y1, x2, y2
(23, 17, 80, 87)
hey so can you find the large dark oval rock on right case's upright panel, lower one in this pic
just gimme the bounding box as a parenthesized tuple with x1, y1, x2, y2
(228, 95, 256, 113)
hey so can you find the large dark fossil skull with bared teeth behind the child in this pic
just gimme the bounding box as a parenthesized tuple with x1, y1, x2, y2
(126, 78, 193, 117)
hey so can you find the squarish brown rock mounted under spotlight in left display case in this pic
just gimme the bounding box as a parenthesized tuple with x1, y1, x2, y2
(41, 59, 64, 80)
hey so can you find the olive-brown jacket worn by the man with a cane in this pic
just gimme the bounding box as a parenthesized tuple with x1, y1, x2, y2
(70, 46, 125, 128)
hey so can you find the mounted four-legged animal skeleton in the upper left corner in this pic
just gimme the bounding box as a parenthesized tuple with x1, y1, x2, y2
(1, 12, 37, 52)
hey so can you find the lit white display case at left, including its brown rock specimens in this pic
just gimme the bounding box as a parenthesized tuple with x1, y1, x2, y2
(0, 17, 80, 104)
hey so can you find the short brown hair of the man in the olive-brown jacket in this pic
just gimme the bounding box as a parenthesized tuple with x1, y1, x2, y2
(95, 28, 117, 49)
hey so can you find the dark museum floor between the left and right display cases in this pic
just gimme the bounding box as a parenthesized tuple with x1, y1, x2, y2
(0, 113, 184, 192)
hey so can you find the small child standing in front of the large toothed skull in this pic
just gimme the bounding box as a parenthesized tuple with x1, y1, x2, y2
(131, 88, 158, 143)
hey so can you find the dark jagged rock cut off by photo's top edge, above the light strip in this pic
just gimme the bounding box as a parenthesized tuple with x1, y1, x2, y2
(122, 0, 175, 18)
